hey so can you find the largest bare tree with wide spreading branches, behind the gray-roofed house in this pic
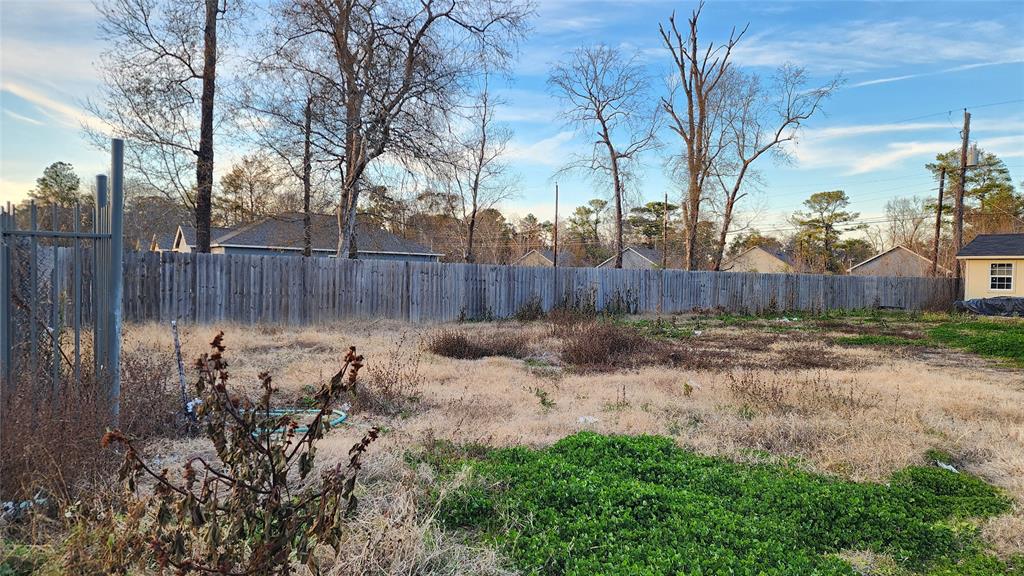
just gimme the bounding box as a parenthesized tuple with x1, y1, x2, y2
(283, 0, 530, 257)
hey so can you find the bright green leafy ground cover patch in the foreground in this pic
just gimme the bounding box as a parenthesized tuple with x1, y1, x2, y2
(430, 433, 1024, 575)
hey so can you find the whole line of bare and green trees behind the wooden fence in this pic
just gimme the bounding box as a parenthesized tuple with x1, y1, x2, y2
(16, 0, 1021, 272)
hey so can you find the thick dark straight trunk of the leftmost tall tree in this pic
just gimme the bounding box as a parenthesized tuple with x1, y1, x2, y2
(196, 0, 218, 252)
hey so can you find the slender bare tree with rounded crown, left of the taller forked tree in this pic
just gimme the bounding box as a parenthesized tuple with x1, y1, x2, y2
(548, 44, 657, 268)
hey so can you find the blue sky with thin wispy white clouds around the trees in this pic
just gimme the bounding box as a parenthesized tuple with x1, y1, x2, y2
(0, 0, 1024, 235)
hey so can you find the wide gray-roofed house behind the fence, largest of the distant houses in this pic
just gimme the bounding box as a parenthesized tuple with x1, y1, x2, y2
(173, 212, 441, 262)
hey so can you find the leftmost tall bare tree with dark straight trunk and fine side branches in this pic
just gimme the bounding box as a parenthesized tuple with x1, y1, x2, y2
(87, 0, 229, 252)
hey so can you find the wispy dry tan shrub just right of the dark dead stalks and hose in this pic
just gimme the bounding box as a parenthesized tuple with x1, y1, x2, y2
(352, 332, 426, 416)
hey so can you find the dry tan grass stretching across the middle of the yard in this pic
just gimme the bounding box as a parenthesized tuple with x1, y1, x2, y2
(128, 321, 1024, 553)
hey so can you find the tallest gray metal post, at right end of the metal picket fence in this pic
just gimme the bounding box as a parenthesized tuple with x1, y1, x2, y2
(108, 138, 125, 426)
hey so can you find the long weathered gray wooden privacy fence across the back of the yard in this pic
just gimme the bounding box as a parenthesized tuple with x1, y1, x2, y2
(116, 252, 959, 324)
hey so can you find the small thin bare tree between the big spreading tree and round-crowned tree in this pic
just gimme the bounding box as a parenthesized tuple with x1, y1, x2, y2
(440, 77, 514, 262)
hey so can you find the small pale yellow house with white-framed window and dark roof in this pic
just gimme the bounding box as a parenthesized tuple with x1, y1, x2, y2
(956, 234, 1024, 300)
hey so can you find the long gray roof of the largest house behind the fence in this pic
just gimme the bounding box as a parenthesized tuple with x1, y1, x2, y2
(213, 212, 440, 255)
